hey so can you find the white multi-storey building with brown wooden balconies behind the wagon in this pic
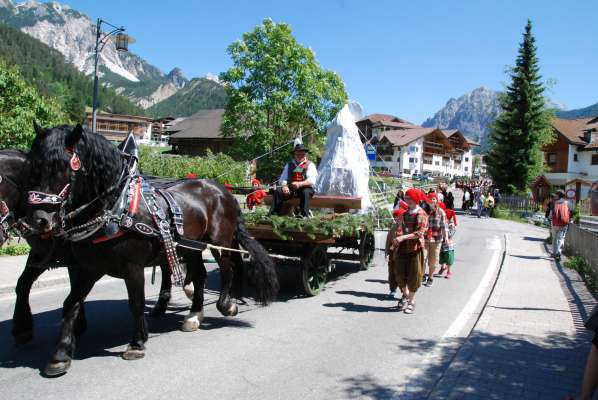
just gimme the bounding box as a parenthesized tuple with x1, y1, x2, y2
(356, 114, 478, 177)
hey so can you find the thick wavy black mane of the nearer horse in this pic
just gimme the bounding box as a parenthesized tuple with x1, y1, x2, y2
(29, 125, 122, 206)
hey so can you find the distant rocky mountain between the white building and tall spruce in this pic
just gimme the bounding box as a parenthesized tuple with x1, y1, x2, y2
(422, 87, 500, 150)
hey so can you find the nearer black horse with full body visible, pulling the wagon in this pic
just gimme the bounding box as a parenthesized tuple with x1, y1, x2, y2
(21, 125, 278, 376)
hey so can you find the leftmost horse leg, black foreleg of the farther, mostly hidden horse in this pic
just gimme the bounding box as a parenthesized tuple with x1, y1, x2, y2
(12, 259, 46, 347)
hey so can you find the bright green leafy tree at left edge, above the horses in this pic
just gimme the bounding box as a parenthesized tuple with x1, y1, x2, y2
(0, 63, 68, 149)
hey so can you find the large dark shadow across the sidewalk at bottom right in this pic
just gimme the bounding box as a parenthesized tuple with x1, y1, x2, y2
(394, 332, 590, 399)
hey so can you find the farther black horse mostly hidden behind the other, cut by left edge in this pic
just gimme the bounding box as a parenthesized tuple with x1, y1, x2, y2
(0, 150, 180, 346)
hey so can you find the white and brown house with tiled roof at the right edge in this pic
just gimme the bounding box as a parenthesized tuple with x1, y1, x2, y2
(543, 116, 598, 200)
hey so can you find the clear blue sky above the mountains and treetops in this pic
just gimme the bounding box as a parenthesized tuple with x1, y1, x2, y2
(51, 0, 598, 123)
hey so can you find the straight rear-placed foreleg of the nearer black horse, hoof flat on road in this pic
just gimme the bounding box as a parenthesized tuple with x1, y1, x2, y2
(122, 264, 148, 360)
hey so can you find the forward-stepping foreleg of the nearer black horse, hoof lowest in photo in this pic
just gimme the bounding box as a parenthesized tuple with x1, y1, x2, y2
(44, 270, 103, 376)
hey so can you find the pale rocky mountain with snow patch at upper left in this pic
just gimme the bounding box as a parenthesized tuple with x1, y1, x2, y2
(0, 0, 224, 116)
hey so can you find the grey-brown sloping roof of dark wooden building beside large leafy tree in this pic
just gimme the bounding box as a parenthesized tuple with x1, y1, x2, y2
(168, 109, 224, 139)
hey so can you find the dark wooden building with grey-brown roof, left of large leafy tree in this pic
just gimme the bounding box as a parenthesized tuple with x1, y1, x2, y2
(168, 109, 233, 156)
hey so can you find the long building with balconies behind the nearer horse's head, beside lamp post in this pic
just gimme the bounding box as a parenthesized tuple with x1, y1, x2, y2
(85, 112, 152, 143)
